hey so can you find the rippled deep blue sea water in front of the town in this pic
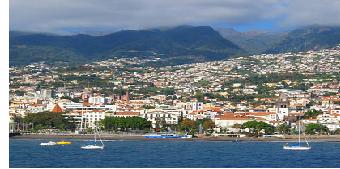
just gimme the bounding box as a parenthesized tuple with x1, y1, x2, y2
(9, 139, 340, 168)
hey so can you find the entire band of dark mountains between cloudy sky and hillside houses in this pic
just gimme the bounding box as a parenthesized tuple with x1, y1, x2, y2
(10, 25, 340, 66)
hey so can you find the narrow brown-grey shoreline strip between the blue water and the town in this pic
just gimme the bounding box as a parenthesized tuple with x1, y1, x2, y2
(9, 134, 340, 142)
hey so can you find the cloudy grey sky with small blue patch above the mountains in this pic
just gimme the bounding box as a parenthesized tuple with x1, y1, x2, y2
(9, 0, 340, 34)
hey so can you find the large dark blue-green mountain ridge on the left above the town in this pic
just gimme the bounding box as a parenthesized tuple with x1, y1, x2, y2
(10, 26, 246, 65)
